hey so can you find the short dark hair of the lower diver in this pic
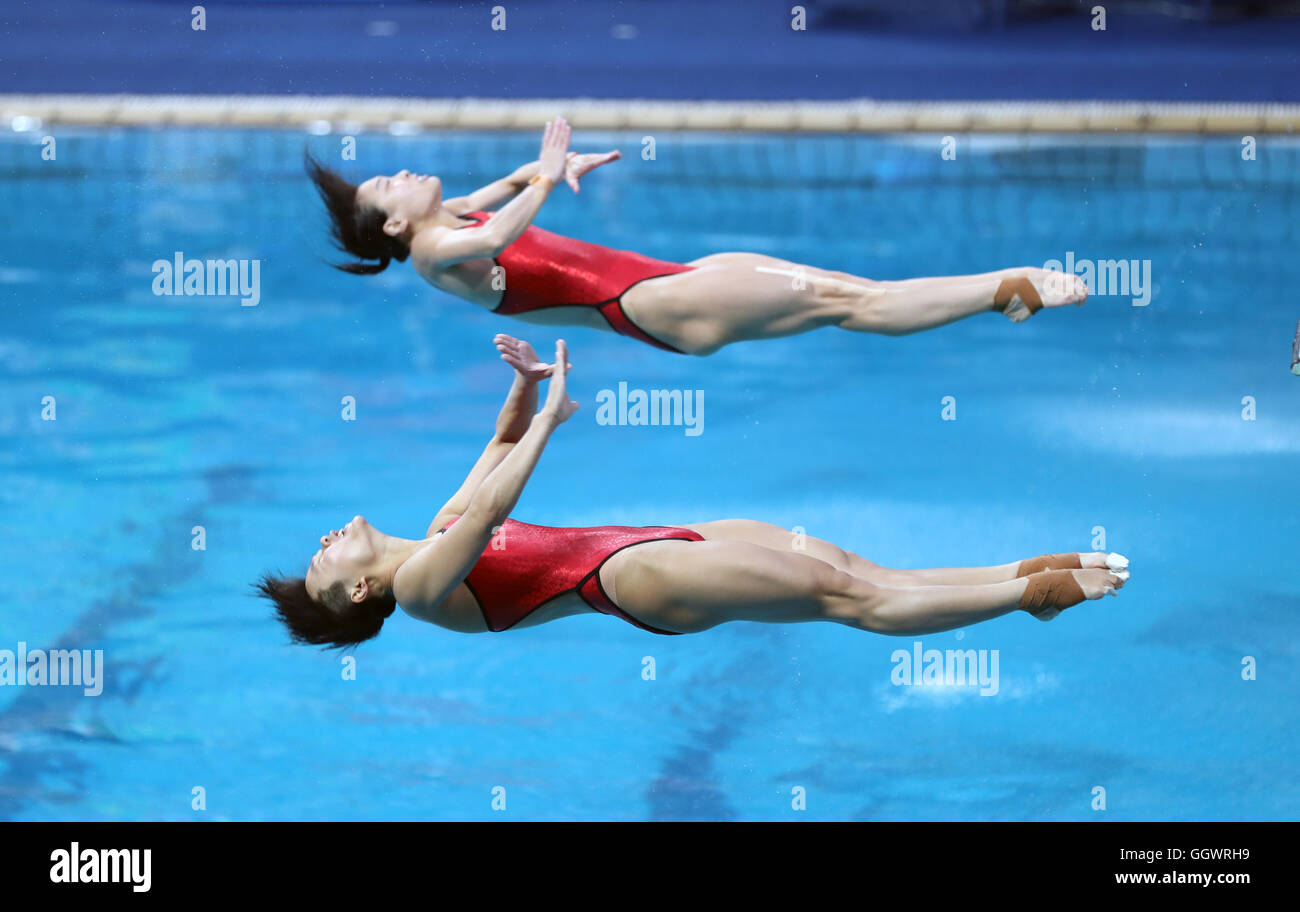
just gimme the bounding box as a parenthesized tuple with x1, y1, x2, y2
(254, 573, 398, 650)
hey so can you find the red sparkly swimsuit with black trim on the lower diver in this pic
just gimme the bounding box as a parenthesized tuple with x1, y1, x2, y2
(443, 520, 705, 635)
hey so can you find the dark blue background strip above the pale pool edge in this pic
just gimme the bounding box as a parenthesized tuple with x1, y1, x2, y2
(0, 0, 1300, 101)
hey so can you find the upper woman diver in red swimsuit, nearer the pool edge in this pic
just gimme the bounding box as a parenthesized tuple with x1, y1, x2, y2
(307, 118, 1088, 355)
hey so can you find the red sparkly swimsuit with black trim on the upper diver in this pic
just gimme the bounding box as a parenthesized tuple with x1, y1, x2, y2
(464, 212, 694, 355)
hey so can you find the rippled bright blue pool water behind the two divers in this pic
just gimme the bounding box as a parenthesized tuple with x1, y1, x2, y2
(0, 130, 1300, 820)
